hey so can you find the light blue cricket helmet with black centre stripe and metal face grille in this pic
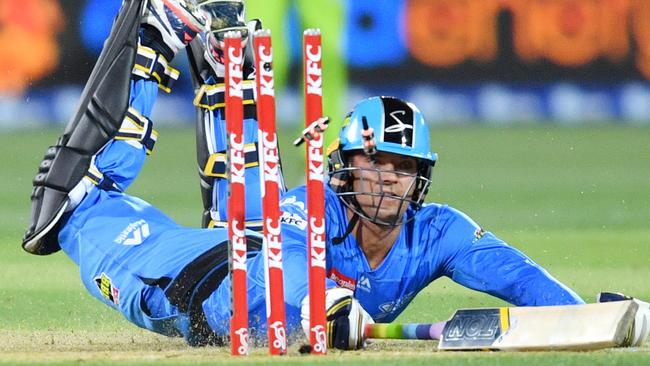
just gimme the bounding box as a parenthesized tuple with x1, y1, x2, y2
(328, 96, 438, 225)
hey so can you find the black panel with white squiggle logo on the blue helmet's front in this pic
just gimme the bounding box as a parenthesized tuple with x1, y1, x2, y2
(382, 98, 413, 147)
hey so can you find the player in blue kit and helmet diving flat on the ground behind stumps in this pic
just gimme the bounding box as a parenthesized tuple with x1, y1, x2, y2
(23, 0, 647, 349)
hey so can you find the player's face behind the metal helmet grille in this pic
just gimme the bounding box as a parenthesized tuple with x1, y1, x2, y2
(350, 152, 417, 223)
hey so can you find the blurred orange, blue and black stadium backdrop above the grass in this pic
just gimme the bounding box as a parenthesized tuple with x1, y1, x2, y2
(0, 0, 650, 131)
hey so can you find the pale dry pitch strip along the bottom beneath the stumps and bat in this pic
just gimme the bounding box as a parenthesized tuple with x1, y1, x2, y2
(0, 329, 650, 366)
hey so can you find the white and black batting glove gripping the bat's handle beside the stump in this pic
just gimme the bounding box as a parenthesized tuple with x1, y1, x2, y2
(301, 287, 374, 350)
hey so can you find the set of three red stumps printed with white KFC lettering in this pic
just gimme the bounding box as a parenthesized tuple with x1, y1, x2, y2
(224, 29, 327, 355)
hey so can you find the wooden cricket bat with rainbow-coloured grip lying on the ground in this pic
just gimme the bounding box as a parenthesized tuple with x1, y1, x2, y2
(365, 300, 638, 351)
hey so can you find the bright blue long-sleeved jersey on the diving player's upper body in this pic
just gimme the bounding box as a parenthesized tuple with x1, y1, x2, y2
(204, 186, 583, 338)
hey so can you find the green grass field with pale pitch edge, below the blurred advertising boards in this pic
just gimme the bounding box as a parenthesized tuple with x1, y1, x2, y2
(0, 125, 650, 365)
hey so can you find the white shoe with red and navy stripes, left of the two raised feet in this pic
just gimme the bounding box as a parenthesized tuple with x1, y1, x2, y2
(142, 0, 206, 61)
